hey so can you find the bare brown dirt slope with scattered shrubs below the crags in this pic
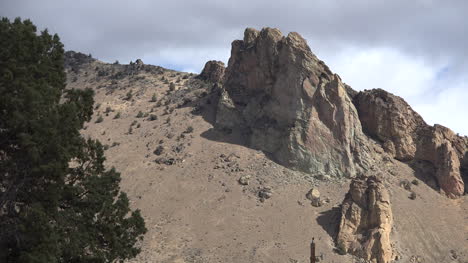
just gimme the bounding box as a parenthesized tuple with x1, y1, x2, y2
(67, 53, 468, 263)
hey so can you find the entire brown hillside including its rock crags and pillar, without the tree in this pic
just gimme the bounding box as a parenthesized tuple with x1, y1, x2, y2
(66, 28, 468, 263)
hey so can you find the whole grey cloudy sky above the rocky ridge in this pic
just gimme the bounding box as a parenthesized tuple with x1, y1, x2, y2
(0, 0, 468, 135)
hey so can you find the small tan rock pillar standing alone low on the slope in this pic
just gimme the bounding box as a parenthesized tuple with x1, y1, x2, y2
(336, 176, 393, 263)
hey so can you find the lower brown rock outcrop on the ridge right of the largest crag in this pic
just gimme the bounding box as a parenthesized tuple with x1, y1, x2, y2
(355, 89, 468, 198)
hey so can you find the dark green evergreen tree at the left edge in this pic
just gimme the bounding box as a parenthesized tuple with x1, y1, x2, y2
(0, 18, 146, 263)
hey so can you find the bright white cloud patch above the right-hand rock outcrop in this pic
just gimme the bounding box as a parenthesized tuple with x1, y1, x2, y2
(321, 48, 468, 135)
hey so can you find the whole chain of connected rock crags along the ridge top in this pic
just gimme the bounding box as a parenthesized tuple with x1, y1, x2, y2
(207, 28, 468, 198)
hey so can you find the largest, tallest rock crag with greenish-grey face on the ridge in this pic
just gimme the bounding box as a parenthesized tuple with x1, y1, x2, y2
(216, 28, 372, 176)
